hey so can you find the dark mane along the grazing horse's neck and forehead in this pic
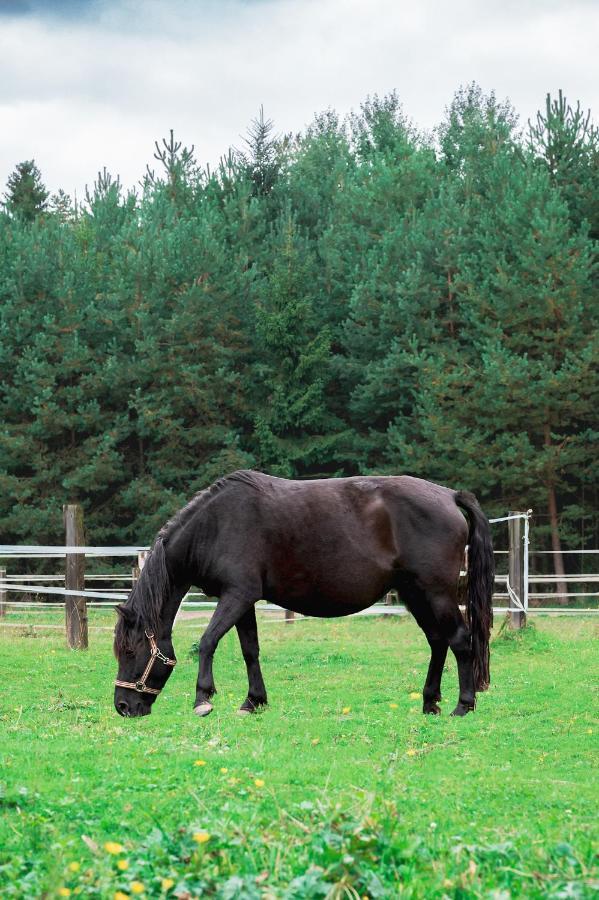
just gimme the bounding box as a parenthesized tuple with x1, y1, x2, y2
(114, 469, 262, 656)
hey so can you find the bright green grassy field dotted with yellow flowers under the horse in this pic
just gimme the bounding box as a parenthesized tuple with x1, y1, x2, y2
(0, 614, 599, 900)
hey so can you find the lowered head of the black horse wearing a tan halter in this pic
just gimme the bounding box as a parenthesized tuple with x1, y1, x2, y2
(114, 606, 176, 717)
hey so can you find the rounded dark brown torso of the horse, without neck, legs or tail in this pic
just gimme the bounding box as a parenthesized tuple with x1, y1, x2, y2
(199, 472, 465, 615)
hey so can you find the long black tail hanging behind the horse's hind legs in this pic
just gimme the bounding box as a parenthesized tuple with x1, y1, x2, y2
(455, 491, 495, 691)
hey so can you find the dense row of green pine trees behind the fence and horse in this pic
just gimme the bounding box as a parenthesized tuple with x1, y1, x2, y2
(0, 86, 599, 564)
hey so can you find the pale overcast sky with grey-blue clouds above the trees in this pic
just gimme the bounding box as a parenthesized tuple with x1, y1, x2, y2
(0, 0, 599, 195)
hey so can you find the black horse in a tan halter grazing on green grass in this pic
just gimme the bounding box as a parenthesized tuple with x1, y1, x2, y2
(114, 471, 494, 716)
